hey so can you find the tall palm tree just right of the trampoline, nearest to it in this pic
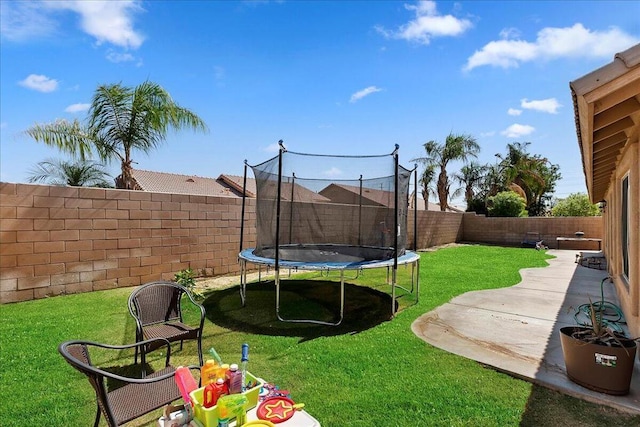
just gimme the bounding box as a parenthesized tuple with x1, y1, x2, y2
(412, 133, 480, 211)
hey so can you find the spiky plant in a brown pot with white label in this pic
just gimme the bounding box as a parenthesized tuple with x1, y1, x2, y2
(560, 290, 637, 395)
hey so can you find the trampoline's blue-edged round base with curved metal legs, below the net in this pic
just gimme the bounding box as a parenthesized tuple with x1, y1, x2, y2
(238, 248, 420, 326)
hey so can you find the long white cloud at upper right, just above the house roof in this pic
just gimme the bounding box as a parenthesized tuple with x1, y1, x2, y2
(464, 23, 640, 71)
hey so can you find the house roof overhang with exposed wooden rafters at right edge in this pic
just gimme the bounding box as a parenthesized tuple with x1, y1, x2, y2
(569, 44, 640, 203)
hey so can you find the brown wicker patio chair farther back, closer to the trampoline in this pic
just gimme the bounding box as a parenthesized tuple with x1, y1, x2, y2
(129, 281, 205, 373)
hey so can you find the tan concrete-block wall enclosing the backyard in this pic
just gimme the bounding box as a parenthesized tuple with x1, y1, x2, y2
(0, 183, 603, 303)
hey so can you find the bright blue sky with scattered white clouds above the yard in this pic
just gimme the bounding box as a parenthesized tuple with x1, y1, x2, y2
(0, 0, 640, 206)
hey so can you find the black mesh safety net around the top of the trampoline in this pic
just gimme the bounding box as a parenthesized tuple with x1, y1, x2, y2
(251, 147, 412, 262)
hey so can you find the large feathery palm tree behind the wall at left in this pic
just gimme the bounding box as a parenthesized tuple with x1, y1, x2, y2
(25, 81, 207, 189)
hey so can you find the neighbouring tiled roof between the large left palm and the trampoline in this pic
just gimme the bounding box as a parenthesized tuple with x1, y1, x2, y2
(133, 169, 242, 197)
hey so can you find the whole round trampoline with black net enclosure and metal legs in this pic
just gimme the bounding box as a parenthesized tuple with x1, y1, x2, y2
(238, 141, 420, 326)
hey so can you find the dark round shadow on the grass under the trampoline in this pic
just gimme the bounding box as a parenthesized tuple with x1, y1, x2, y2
(203, 280, 391, 341)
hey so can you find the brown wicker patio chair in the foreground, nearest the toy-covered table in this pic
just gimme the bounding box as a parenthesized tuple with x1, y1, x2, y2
(58, 339, 198, 427)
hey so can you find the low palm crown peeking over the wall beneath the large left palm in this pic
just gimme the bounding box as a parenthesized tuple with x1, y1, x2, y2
(28, 159, 113, 188)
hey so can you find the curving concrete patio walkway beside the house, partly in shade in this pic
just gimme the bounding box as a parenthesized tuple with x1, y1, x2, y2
(412, 250, 640, 414)
